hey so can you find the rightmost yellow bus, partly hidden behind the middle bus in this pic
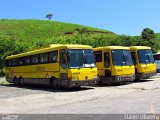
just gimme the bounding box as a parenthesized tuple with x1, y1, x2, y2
(130, 46, 156, 80)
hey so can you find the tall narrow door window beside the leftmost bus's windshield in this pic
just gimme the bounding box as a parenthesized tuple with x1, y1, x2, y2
(60, 50, 67, 69)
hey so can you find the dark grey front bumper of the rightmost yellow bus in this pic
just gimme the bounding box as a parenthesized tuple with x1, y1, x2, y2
(136, 71, 157, 80)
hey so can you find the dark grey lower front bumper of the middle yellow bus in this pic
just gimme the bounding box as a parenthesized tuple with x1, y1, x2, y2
(100, 75, 135, 84)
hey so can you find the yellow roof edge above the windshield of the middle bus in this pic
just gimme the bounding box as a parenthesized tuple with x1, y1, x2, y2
(93, 46, 129, 51)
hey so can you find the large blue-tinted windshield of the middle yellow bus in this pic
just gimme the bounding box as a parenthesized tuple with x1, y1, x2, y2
(112, 50, 133, 66)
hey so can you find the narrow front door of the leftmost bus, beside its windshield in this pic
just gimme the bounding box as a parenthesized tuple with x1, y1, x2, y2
(60, 50, 68, 80)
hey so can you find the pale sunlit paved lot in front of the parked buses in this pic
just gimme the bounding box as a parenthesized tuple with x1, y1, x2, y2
(0, 74, 160, 114)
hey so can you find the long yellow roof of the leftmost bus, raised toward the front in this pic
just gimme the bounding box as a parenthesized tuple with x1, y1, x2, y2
(6, 44, 92, 60)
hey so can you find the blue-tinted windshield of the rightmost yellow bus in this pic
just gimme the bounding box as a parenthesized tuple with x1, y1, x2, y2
(138, 50, 154, 64)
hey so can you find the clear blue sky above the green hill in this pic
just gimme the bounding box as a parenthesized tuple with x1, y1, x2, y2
(0, 0, 160, 36)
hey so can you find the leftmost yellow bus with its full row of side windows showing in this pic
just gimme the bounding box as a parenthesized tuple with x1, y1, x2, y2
(5, 44, 97, 88)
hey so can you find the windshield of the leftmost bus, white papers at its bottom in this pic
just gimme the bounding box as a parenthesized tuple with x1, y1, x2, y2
(68, 49, 96, 68)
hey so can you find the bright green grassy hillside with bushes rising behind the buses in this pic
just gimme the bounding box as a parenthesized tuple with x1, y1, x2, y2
(0, 19, 117, 68)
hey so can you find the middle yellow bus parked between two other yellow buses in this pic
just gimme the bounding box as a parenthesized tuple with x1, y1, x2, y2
(93, 46, 135, 84)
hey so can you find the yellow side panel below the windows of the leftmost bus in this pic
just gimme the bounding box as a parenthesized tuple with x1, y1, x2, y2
(6, 63, 60, 82)
